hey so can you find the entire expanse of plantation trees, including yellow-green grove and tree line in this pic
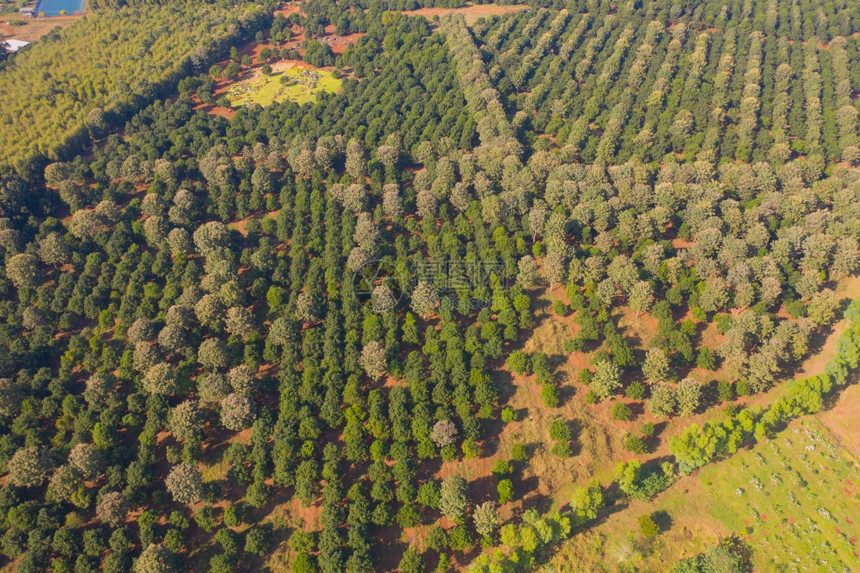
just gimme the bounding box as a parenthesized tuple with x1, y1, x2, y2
(0, 0, 860, 573)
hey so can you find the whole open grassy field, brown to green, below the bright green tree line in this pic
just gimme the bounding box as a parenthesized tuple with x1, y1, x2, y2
(552, 418, 860, 572)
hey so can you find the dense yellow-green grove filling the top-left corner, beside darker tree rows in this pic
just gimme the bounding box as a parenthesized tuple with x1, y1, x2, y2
(0, 1, 265, 168)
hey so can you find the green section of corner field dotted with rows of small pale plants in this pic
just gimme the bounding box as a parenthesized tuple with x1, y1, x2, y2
(701, 419, 860, 571)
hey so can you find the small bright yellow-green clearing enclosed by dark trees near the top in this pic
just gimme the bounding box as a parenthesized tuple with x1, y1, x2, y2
(226, 63, 341, 107)
